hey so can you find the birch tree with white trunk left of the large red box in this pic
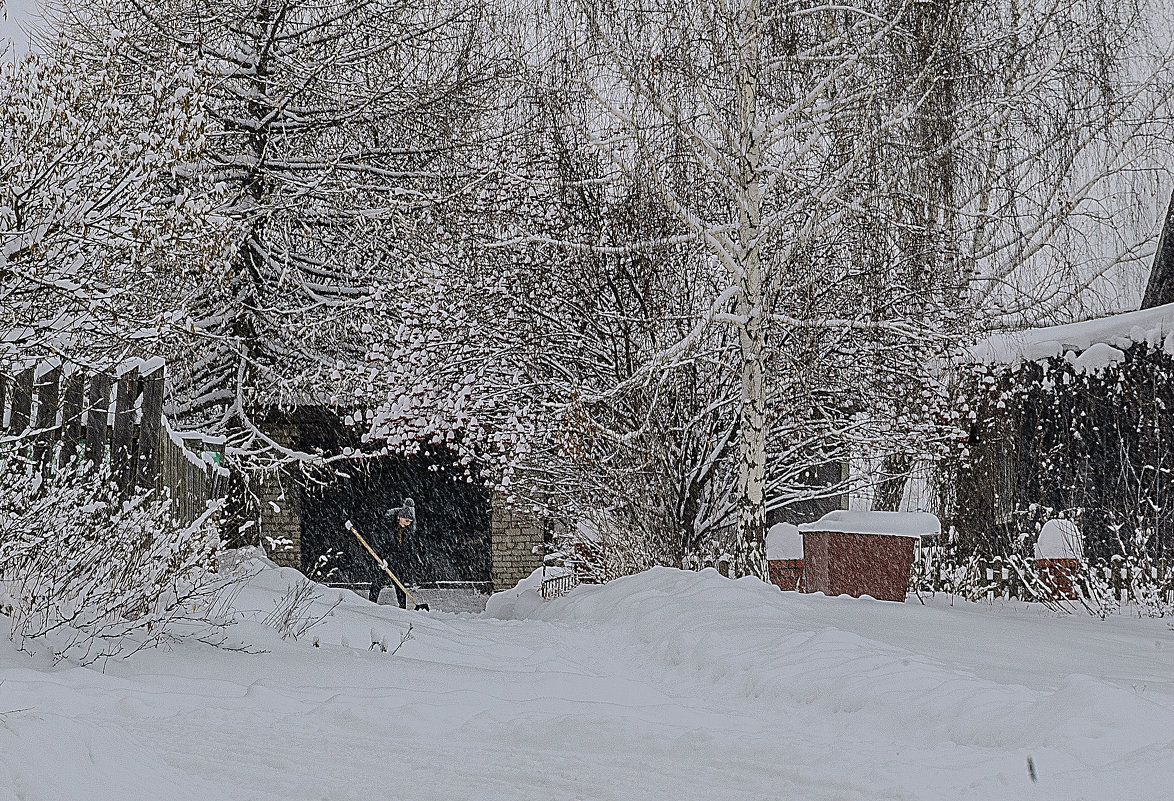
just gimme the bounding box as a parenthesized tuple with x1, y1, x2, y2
(549, 0, 953, 575)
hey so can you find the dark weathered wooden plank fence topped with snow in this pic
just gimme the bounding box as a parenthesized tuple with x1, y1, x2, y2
(0, 359, 227, 523)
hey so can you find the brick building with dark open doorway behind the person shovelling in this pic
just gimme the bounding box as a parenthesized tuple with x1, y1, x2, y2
(235, 408, 545, 591)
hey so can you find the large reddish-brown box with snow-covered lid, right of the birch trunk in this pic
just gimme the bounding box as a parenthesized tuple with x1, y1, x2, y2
(798, 511, 942, 601)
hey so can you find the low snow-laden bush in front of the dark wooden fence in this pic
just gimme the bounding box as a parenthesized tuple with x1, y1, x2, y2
(0, 455, 224, 664)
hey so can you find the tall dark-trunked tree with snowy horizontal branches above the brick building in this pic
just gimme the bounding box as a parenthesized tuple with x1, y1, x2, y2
(46, 0, 528, 465)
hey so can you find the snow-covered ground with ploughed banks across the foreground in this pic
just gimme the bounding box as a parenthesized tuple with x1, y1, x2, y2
(0, 559, 1174, 801)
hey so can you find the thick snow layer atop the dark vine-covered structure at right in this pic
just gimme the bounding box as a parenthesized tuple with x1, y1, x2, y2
(970, 303, 1174, 372)
